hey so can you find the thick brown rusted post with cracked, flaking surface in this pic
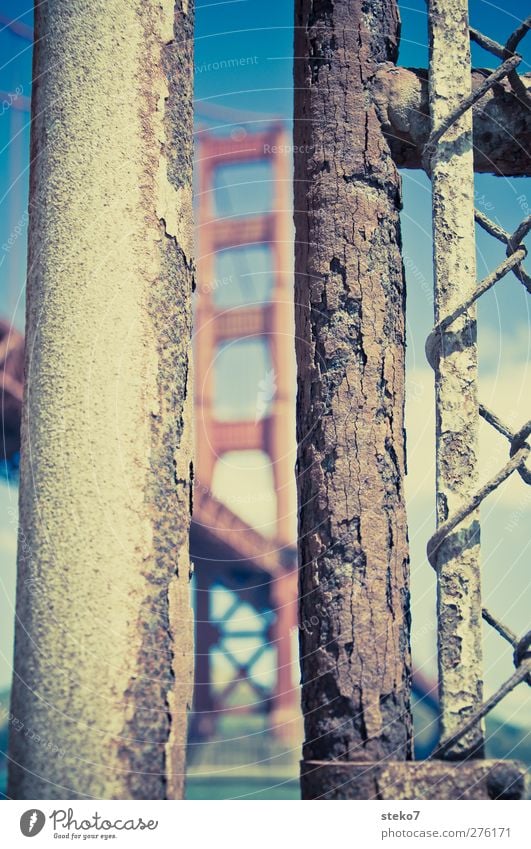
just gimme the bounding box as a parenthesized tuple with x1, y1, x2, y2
(294, 0, 411, 794)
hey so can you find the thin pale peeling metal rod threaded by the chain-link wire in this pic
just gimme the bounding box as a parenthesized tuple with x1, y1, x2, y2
(429, 0, 483, 758)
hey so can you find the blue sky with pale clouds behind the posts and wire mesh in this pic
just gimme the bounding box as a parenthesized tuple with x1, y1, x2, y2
(0, 0, 531, 732)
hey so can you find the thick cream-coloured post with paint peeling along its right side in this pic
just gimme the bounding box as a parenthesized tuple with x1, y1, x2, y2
(8, 0, 193, 799)
